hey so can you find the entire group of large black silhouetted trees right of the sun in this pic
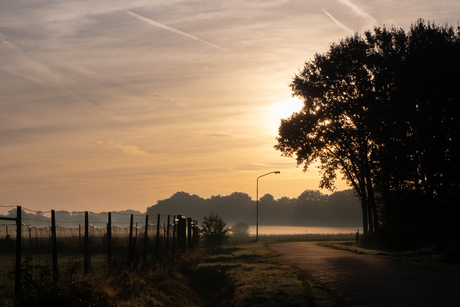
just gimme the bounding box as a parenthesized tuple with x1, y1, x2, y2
(275, 20, 460, 245)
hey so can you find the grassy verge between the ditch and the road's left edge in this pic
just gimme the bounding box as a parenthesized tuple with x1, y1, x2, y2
(192, 242, 348, 307)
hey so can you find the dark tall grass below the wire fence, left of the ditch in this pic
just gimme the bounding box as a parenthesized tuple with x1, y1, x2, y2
(0, 248, 203, 307)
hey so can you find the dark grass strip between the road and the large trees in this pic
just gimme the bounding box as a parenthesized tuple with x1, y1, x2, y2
(319, 241, 460, 276)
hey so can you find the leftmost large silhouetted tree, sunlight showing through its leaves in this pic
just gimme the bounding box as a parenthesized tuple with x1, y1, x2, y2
(275, 31, 378, 232)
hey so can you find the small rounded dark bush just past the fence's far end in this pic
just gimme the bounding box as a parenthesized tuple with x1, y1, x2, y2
(201, 213, 230, 250)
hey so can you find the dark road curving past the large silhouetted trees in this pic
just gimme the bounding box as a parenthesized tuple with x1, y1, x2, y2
(269, 242, 460, 307)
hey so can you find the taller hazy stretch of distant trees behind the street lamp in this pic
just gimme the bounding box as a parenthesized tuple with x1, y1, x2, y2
(147, 190, 362, 227)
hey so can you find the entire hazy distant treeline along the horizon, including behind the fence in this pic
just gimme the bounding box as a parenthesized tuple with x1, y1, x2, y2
(1, 190, 362, 227)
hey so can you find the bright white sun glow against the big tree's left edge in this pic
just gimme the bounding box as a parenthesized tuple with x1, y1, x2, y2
(267, 97, 303, 135)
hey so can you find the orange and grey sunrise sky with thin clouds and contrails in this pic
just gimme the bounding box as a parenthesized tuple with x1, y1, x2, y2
(0, 0, 460, 213)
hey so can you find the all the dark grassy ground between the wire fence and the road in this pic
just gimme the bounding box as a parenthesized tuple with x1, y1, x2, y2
(0, 237, 347, 307)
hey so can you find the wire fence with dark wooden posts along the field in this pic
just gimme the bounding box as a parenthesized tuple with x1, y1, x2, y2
(0, 206, 199, 306)
